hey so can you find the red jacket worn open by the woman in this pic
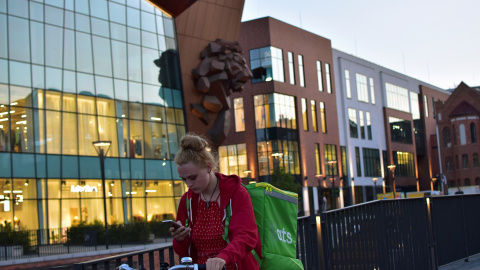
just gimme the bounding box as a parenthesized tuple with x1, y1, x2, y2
(173, 173, 262, 270)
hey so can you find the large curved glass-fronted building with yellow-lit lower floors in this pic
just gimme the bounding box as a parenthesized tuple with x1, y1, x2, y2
(0, 0, 186, 232)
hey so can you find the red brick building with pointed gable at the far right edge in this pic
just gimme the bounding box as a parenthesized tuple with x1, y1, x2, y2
(435, 82, 480, 193)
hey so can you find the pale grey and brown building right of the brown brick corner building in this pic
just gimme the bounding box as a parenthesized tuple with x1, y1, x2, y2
(333, 49, 450, 203)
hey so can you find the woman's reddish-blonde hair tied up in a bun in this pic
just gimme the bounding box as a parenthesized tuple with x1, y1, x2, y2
(175, 133, 218, 170)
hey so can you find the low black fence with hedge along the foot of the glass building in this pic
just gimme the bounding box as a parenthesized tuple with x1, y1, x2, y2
(0, 222, 171, 261)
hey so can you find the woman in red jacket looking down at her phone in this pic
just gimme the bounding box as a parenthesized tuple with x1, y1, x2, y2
(170, 134, 261, 270)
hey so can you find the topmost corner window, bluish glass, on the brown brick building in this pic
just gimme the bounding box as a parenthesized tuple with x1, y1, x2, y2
(250, 47, 285, 83)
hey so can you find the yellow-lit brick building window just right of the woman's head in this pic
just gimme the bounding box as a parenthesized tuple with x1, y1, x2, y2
(218, 144, 249, 177)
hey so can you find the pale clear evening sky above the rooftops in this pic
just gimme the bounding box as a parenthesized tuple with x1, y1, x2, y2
(242, 0, 480, 89)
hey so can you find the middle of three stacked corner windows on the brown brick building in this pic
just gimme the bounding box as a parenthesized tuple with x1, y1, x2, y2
(253, 93, 297, 129)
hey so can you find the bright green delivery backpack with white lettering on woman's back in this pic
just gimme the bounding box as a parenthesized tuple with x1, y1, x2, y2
(223, 182, 303, 270)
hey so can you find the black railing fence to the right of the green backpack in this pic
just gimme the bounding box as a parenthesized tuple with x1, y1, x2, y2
(297, 194, 480, 270)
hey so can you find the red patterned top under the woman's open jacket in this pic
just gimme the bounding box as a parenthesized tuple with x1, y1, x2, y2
(192, 199, 237, 270)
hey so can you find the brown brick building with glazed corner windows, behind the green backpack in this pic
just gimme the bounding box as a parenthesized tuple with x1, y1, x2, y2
(219, 17, 344, 212)
